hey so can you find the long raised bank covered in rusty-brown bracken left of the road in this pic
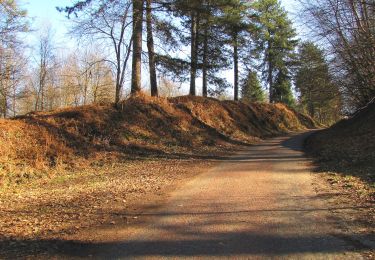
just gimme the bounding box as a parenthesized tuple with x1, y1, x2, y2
(0, 96, 315, 185)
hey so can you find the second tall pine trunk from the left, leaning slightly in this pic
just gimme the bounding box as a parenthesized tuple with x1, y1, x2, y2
(146, 0, 158, 97)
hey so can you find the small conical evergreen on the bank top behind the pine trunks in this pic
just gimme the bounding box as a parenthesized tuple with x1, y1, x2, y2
(241, 71, 266, 102)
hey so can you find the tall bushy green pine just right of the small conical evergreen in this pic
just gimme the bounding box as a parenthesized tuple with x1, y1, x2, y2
(253, 0, 297, 105)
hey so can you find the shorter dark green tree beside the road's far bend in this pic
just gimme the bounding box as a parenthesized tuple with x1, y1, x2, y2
(295, 42, 341, 124)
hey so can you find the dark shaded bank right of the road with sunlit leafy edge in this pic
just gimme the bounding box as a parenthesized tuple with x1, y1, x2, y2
(306, 101, 375, 202)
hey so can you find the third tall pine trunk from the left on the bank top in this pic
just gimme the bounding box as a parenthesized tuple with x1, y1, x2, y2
(189, 10, 198, 96)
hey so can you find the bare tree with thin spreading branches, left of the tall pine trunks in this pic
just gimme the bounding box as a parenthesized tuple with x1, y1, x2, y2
(71, 0, 133, 104)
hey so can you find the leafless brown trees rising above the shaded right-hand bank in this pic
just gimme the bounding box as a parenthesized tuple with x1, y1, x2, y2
(300, 0, 375, 110)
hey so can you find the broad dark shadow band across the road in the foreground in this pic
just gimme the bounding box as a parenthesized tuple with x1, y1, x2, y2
(0, 232, 368, 259)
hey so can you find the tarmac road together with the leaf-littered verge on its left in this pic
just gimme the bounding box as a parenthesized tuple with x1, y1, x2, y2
(0, 134, 375, 259)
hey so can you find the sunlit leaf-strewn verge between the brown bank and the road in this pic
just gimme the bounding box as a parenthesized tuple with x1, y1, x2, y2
(0, 159, 214, 258)
